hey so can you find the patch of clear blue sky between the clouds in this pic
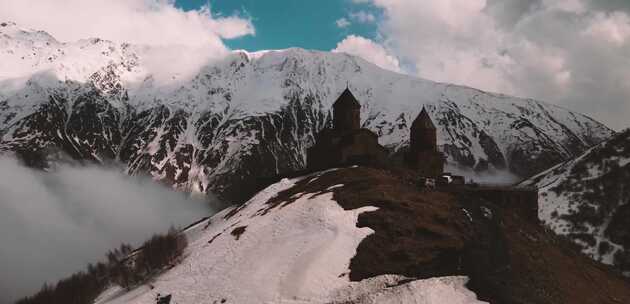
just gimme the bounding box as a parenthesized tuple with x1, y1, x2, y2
(176, 0, 379, 51)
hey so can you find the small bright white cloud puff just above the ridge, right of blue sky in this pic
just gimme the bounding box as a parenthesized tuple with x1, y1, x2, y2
(333, 35, 400, 72)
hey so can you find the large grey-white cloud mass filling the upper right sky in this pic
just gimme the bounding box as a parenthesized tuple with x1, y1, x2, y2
(344, 0, 630, 129)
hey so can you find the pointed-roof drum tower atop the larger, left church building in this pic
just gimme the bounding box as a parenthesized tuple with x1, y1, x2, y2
(333, 88, 361, 131)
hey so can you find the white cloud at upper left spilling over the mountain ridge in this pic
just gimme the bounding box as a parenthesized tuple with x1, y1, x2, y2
(0, 0, 255, 90)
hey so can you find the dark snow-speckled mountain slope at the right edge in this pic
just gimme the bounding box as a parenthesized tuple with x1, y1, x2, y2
(523, 130, 630, 276)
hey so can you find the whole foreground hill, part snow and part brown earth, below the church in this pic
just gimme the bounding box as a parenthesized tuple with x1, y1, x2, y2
(95, 167, 630, 304)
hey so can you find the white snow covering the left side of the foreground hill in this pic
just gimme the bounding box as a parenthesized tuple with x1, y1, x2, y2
(95, 171, 485, 304)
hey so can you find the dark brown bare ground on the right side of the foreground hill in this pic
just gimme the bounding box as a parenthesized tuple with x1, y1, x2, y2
(268, 167, 630, 304)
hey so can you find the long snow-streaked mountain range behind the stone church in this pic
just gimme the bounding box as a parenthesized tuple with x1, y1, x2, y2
(0, 22, 613, 201)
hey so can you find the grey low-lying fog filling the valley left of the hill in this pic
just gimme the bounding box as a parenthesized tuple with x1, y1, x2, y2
(0, 156, 217, 303)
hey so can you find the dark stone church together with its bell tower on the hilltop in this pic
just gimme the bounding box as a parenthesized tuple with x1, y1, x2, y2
(307, 88, 444, 177)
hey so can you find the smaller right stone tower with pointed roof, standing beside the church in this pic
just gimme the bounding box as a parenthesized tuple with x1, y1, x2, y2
(405, 107, 444, 177)
